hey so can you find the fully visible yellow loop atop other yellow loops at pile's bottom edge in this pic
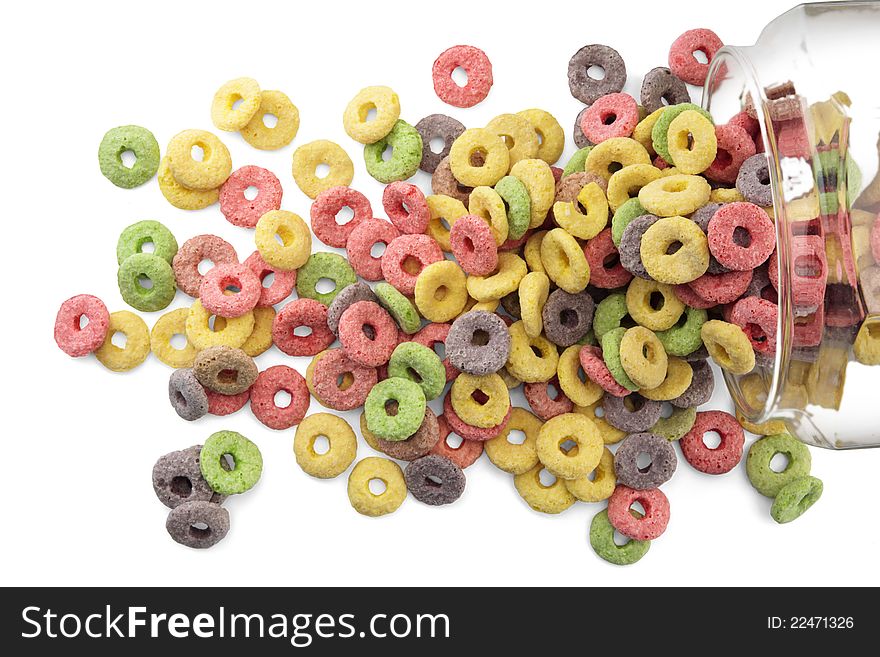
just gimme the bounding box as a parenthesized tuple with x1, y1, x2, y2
(535, 413, 605, 479)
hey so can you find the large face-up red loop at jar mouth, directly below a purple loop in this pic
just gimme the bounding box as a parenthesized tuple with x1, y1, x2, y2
(706, 201, 776, 271)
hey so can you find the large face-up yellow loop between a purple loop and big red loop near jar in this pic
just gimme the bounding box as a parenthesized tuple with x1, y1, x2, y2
(639, 217, 709, 285)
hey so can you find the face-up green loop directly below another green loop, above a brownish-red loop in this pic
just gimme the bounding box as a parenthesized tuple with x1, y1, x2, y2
(364, 377, 426, 441)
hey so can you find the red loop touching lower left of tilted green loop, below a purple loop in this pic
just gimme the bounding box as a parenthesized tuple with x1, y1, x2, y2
(339, 301, 399, 367)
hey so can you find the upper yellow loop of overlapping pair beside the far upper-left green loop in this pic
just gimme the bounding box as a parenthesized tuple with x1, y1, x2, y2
(165, 130, 232, 192)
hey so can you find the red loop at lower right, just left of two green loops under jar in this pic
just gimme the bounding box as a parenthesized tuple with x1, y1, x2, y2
(678, 411, 745, 474)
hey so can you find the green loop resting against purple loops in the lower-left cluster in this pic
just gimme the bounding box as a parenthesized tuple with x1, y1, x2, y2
(199, 431, 263, 495)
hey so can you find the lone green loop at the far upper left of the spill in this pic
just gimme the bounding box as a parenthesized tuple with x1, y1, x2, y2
(98, 125, 160, 189)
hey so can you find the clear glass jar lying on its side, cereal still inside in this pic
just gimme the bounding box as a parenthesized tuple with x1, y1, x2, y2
(703, 2, 880, 448)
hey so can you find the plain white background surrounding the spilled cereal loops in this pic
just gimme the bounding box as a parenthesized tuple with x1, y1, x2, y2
(0, 0, 880, 586)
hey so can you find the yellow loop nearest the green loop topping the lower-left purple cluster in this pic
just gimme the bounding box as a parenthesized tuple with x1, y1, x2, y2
(293, 413, 357, 479)
